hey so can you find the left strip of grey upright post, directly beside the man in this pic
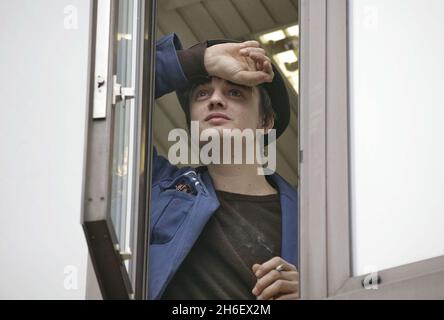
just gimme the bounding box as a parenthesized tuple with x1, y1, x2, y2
(299, 0, 327, 299)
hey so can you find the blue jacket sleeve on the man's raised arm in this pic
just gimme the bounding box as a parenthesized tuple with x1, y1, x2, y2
(155, 33, 188, 99)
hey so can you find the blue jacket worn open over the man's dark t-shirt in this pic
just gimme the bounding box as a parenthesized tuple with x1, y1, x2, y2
(148, 34, 299, 299)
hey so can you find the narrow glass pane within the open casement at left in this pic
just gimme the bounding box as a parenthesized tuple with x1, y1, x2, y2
(111, 0, 135, 264)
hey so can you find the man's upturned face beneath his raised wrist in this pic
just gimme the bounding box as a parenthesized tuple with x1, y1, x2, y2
(190, 77, 263, 134)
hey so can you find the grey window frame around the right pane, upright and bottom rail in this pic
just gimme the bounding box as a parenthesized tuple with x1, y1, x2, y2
(300, 0, 444, 299)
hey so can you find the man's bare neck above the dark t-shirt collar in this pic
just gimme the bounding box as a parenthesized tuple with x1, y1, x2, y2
(208, 164, 277, 196)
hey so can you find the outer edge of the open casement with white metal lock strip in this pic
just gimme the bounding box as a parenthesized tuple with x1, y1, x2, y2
(82, 0, 131, 299)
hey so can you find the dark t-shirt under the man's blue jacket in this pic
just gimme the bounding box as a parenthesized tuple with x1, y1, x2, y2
(161, 191, 282, 300)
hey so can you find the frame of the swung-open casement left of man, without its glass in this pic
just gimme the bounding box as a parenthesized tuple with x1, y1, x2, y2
(81, 0, 157, 299)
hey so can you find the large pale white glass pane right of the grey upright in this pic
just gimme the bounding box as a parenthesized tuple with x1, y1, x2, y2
(349, 0, 444, 275)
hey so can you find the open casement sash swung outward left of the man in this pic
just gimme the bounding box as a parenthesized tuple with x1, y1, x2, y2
(82, 0, 156, 299)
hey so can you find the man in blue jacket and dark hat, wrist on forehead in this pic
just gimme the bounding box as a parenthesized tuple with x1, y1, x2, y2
(149, 35, 299, 299)
